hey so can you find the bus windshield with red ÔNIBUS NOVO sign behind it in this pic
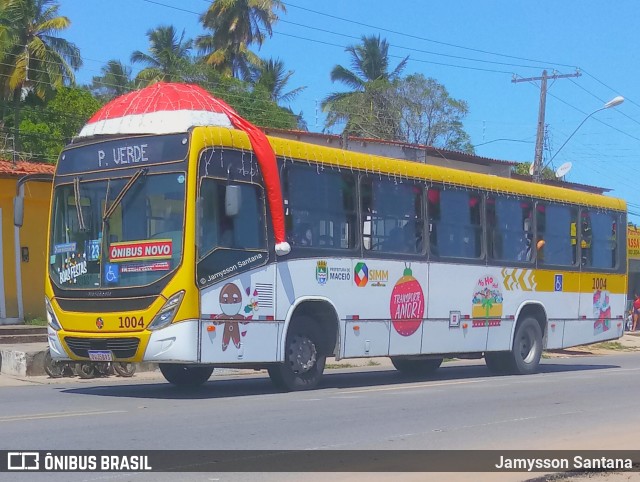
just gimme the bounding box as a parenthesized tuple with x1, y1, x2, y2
(49, 171, 185, 289)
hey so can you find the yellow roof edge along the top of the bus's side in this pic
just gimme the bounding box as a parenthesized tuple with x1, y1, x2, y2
(194, 127, 626, 211)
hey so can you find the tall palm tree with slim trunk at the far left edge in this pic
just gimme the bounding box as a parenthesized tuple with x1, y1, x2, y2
(0, 0, 82, 150)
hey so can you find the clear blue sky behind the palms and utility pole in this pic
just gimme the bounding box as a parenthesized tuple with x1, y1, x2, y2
(60, 0, 640, 223)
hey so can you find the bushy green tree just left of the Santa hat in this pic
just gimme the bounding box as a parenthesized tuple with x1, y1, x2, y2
(20, 87, 103, 164)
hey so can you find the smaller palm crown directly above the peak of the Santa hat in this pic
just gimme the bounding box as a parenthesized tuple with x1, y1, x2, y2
(131, 25, 193, 86)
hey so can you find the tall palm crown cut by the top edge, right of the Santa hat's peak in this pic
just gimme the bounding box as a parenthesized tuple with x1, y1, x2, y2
(196, 0, 286, 79)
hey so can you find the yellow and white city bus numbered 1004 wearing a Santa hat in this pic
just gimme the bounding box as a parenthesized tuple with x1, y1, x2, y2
(30, 84, 627, 390)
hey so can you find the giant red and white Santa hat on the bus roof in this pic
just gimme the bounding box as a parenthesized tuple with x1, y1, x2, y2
(78, 82, 291, 255)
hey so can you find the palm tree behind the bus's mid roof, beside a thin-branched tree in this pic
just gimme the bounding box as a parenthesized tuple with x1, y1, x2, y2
(321, 35, 409, 138)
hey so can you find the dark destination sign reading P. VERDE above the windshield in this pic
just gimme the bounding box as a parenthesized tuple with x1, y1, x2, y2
(57, 134, 189, 176)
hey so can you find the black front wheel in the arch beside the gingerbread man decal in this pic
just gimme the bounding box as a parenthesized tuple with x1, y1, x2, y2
(268, 319, 327, 392)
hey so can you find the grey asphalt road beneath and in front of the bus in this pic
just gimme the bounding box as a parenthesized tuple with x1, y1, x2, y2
(0, 353, 640, 480)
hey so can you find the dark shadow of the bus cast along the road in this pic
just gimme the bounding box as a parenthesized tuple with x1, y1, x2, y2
(61, 361, 620, 400)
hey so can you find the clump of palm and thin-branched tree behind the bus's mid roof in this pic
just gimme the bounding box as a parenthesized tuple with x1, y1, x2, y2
(322, 36, 473, 152)
